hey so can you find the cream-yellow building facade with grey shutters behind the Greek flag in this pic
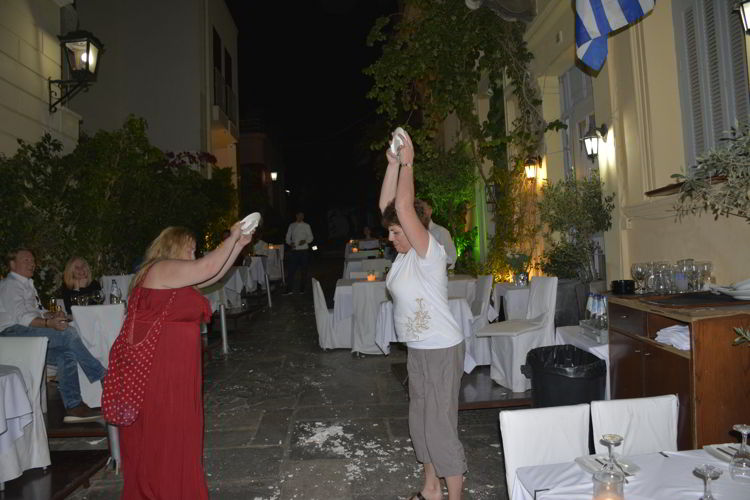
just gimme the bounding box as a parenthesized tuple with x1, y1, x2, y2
(516, 0, 750, 283)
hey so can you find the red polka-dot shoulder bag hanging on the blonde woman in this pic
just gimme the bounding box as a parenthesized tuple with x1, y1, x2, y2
(102, 286, 177, 426)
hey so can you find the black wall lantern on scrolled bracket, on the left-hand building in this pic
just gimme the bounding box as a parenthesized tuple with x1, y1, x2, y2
(47, 30, 104, 113)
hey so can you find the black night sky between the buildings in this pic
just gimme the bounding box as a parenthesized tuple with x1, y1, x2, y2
(227, 0, 397, 238)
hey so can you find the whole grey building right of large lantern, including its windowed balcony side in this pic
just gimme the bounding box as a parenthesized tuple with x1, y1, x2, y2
(70, 0, 239, 179)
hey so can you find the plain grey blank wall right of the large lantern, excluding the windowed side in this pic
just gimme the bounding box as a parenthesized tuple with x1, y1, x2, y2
(71, 0, 208, 151)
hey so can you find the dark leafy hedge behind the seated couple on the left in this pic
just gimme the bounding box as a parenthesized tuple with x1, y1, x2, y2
(0, 117, 237, 297)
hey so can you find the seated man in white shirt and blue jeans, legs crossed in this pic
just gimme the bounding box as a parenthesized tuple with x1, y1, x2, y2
(0, 248, 107, 423)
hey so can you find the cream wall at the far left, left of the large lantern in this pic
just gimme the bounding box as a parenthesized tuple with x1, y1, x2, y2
(0, 0, 79, 155)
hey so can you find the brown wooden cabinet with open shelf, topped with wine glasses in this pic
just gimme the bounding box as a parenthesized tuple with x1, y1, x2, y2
(609, 297, 750, 449)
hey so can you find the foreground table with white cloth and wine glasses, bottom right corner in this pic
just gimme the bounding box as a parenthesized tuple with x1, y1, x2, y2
(510, 450, 750, 500)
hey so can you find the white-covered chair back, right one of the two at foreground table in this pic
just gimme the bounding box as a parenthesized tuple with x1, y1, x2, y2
(591, 394, 679, 455)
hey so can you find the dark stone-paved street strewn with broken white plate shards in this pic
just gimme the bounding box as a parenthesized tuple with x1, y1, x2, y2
(66, 258, 507, 500)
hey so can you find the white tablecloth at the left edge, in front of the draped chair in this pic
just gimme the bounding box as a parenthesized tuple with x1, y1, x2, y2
(0, 365, 32, 456)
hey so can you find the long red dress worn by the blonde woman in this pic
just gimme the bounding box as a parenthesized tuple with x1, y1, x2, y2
(114, 287, 211, 500)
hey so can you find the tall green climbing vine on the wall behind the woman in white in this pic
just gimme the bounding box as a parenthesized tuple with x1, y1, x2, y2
(365, 0, 560, 275)
